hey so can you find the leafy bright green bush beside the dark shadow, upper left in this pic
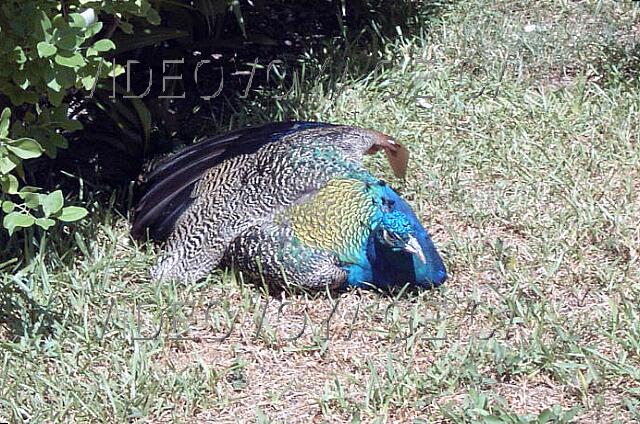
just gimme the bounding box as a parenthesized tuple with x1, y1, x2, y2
(0, 0, 160, 234)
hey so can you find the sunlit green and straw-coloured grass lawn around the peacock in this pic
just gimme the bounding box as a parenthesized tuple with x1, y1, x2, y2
(0, 0, 640, 423)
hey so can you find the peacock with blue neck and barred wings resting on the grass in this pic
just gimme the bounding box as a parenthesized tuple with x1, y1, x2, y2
(131, 121, 447, 289)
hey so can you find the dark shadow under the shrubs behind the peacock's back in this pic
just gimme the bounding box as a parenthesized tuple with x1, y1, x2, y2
(31, 0, 448, 198)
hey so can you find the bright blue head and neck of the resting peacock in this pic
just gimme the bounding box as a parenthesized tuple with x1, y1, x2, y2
(368, 193, 447, 287)
